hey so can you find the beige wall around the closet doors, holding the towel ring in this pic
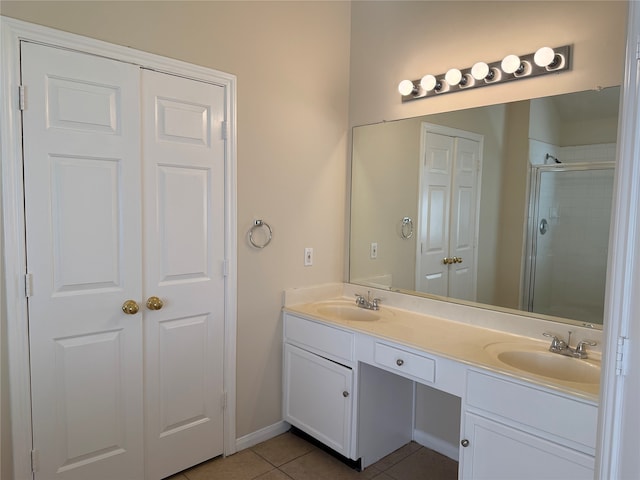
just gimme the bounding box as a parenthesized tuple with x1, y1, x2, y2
(0, 1, 350, 446)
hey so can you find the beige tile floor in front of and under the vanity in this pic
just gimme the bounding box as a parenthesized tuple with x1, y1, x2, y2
(167, 432, 458, 480)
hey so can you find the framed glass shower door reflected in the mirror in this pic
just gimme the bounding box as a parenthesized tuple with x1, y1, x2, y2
(523, 162, 614, 324)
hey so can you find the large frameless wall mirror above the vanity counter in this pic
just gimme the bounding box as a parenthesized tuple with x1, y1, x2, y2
(349, 87, 620, 328)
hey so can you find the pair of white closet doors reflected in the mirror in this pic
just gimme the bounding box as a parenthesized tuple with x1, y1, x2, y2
(416, 127, 481, 301)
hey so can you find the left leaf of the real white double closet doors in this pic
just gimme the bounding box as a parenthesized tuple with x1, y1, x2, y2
(22, 43, 143, 480)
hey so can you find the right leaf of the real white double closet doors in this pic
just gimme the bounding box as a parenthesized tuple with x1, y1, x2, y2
(142, 70, 225, 479)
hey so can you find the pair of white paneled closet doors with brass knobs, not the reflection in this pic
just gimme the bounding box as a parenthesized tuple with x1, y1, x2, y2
(22, 43, 224, 480)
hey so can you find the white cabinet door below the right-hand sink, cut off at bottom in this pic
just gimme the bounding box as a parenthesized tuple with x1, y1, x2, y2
(460, 413, 594, 480)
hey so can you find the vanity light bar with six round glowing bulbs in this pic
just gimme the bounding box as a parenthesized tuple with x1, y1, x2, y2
(398, 45, 571, 103)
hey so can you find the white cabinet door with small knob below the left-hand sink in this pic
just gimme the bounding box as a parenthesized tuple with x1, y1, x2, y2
(283, 343, 353, 457)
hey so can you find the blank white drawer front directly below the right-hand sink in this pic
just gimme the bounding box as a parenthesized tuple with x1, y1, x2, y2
(466, 371, 598, 454)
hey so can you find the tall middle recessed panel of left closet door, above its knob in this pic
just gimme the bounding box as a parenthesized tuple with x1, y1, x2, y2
(50, 155, 123, 295)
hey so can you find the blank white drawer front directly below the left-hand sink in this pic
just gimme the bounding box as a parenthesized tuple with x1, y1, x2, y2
(284, 314, 354, 362)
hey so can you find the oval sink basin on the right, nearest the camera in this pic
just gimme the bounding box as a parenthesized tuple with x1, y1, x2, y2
(485, 343, 600, 385)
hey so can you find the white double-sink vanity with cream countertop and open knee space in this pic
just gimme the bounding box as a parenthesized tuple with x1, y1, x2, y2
(283, 284, 601, 480)
